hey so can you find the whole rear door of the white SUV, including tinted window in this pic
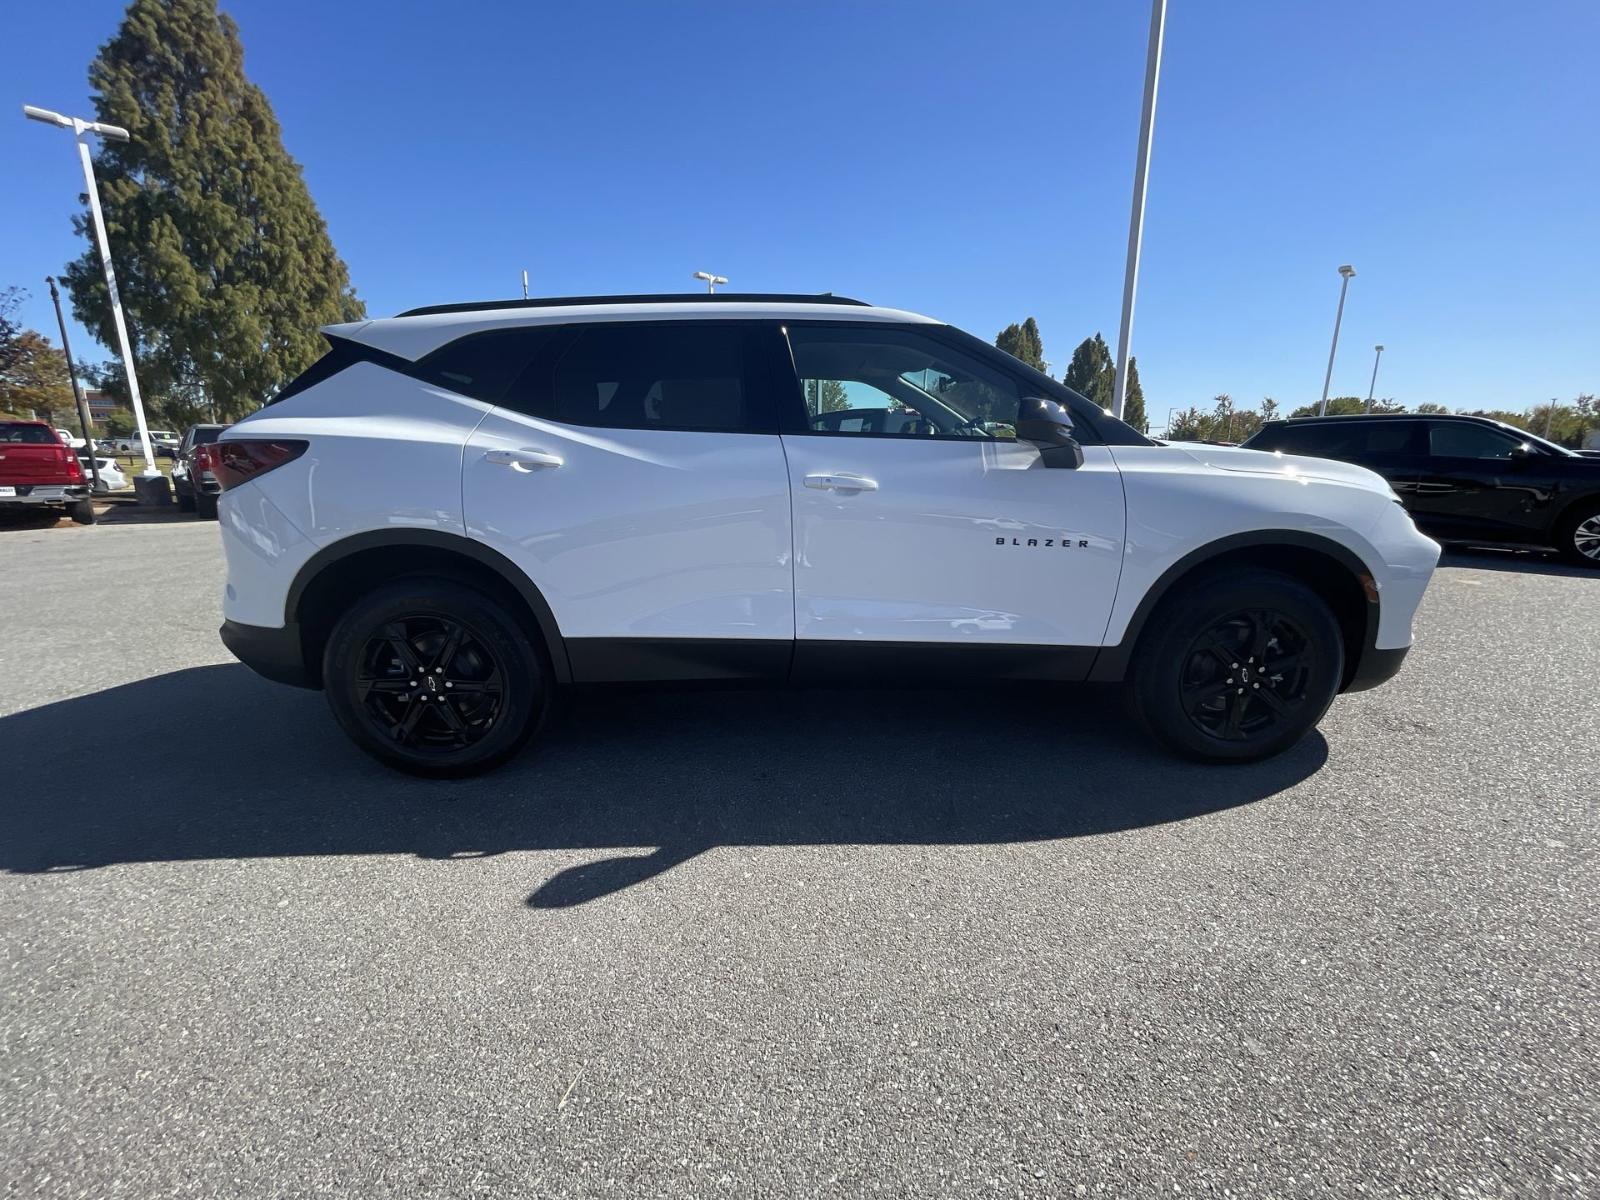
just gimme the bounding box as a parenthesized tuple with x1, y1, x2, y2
(462, 320, 794, 680)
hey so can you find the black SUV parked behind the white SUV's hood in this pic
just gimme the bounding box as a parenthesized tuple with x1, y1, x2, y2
(1245, 413, 1600, 566)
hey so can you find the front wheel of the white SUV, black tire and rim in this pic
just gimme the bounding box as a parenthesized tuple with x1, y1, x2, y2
(1130, 568, 1344, 762)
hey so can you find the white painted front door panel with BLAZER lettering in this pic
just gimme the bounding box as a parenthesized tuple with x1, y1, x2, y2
(784, 435, 1123, 646)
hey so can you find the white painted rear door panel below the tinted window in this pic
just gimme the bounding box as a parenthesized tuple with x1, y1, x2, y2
(461, 410, 794, 640)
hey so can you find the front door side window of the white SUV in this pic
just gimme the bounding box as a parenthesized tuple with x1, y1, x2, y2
(789, 325, 1021, 440)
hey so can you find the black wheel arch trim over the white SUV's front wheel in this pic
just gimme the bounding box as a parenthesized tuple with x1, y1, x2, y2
(1090, 530, 1379, 691)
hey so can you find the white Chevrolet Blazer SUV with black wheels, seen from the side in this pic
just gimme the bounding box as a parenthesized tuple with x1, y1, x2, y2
(213, 294, 1438, 774)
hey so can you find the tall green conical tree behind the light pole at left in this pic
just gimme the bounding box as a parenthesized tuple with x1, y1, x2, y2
(64, 0, 365, 419)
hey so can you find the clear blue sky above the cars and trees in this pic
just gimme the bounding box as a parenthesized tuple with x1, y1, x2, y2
(0, 0, 1600, 427)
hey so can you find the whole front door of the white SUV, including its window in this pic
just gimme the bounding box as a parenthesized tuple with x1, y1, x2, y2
(771, 323, 1125, 678)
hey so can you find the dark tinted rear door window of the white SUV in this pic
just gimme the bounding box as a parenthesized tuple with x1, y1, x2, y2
(541, 322, 752, 434)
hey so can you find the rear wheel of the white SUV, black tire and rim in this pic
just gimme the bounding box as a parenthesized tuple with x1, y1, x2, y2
(322, 576, 552, 778)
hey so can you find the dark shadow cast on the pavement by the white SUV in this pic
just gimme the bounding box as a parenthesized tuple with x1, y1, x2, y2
(0, 664, 1328, 907)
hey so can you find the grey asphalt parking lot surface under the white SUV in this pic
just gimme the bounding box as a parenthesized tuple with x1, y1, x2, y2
(0, 518, 1600, 1197)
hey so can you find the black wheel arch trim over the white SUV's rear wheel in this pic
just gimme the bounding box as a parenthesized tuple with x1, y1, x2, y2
(283, 530, 573, 686)
